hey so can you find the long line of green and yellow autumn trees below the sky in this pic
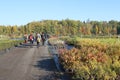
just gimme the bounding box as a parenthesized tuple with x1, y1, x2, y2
(0, 19, 120, 36)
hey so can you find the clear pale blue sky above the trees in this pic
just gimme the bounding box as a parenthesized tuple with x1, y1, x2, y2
(0, 0, 120, 25)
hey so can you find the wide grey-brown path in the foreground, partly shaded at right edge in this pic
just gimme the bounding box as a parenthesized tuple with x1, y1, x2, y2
(0, 43, 61, 80)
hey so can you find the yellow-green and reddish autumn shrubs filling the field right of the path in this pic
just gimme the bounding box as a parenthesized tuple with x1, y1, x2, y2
(59, 37, 120, 80)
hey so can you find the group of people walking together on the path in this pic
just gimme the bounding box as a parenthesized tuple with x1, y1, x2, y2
(24, 32, 46, 46)
